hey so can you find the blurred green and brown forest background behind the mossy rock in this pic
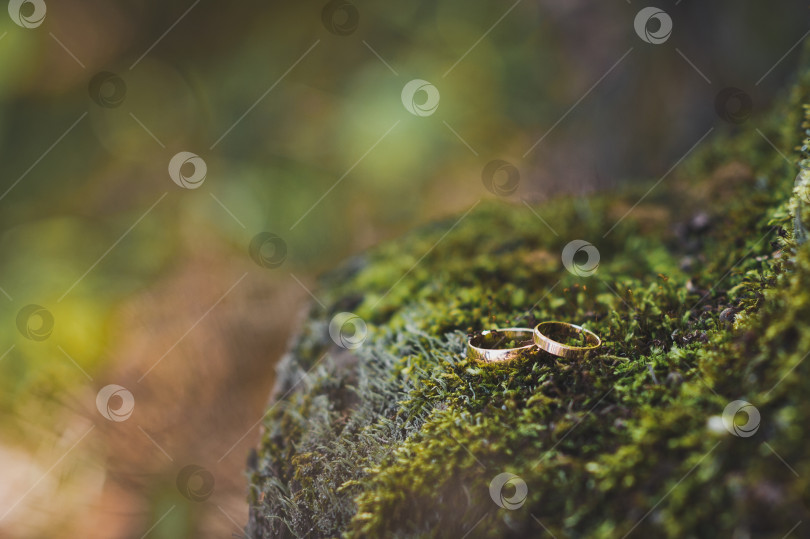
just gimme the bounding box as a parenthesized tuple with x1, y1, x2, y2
(0, 0, 808, 537)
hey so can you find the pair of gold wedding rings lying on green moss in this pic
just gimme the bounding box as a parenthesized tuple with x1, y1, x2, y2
(467, 322, 602, 363)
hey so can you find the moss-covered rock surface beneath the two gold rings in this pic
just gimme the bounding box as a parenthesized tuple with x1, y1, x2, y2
(247, 45, 810, 538)
